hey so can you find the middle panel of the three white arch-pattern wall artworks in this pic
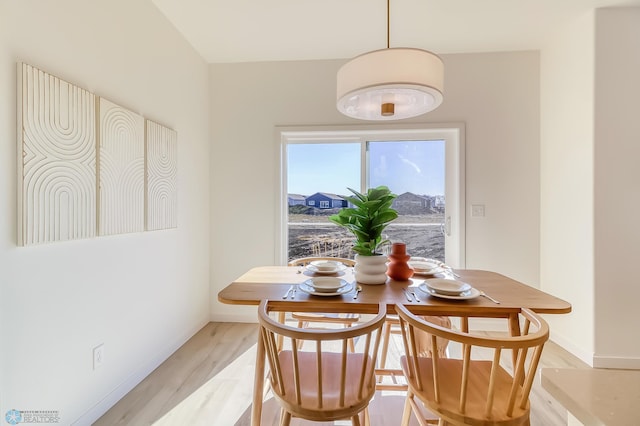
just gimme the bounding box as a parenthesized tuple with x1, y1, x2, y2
(98, 98, 144, 235)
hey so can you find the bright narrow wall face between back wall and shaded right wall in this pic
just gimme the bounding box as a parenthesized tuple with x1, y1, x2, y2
(540, 12, 594, 363)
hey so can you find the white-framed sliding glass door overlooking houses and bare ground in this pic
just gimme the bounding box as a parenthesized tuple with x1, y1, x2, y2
(277, 125, 464, 267)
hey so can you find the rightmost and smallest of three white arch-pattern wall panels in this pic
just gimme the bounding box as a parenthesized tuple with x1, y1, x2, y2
(146, 120, 178, 231)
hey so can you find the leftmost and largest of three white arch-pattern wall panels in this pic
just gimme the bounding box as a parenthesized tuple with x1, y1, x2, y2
(17, 63, 96, 245)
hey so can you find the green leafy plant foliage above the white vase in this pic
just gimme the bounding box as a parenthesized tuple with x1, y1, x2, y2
(329, 186, 398, 256)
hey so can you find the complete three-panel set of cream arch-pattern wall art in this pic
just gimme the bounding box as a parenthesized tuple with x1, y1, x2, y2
(16, 63, 178, 245)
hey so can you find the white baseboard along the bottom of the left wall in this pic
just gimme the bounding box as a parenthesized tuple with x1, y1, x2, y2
(71, 323, 206, 426)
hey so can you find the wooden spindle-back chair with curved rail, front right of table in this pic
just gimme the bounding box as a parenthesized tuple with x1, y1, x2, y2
(396, 305, 549, 426)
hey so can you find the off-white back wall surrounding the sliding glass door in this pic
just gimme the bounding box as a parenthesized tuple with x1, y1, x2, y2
(210, 52, 540, 321)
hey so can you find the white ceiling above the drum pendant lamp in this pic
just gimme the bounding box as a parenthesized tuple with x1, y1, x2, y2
(152, 0, 640, 63)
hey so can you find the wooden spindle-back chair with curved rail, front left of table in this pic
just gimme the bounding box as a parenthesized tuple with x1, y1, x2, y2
(258, 300, 386, 426)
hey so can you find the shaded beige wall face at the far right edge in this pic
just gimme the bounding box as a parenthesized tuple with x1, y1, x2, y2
(594, 8, 640, 369)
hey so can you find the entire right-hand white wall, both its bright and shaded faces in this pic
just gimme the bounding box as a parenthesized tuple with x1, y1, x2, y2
(540, 8, 640, 369)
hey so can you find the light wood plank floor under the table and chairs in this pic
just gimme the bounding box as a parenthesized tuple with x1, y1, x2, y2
(94, 323, 587, 426)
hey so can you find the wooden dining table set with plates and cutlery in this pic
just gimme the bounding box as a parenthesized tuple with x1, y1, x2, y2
(218, 266, 571, 426)
